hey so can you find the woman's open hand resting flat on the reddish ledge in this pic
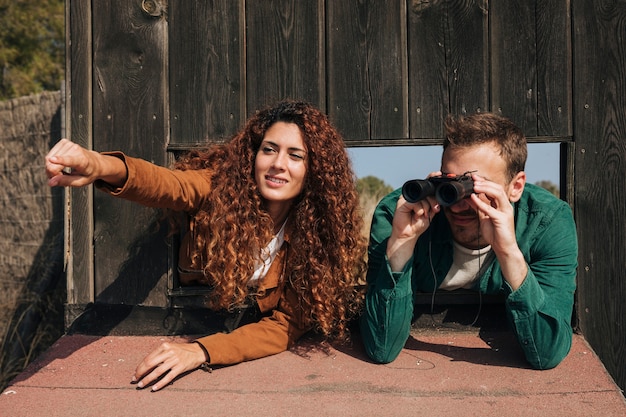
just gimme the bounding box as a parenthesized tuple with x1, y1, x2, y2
(131, 342, 207, 391)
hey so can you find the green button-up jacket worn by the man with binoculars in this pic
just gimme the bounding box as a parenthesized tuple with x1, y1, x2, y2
(361, 184, 578, 369)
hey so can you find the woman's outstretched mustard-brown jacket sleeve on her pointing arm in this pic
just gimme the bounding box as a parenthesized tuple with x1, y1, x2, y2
(95, 152, 211, 212)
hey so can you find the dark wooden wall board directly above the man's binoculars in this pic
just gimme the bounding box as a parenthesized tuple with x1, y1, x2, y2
(409, 0, 489, 138)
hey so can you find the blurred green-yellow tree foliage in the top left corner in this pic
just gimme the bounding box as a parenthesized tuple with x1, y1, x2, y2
(0, 0, 65, 100)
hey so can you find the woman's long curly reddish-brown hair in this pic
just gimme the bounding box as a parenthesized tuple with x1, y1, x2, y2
(175, 100, 367, 338)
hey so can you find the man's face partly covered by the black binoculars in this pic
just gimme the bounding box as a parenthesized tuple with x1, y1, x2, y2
(441, 142, 510, 249)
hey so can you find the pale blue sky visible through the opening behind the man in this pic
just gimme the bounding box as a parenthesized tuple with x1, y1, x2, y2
(348, 143, 560, 188)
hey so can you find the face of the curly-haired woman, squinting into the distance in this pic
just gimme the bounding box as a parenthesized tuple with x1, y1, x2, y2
(254, 122, 307, 212)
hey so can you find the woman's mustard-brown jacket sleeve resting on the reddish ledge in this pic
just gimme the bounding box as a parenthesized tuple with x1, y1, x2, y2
(198, 284, 309, 365)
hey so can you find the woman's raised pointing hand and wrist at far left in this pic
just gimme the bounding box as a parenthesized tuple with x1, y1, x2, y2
(45, 139, 128, 187)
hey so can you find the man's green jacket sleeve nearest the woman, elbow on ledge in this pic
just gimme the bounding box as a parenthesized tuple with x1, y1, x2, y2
(360, 193, 413, 363)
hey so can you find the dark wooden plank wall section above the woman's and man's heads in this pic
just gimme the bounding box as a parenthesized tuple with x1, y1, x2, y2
(162, 0, 571, 149)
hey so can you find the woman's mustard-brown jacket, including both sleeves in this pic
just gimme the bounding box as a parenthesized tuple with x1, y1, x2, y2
(96, 152, 309, 365)
